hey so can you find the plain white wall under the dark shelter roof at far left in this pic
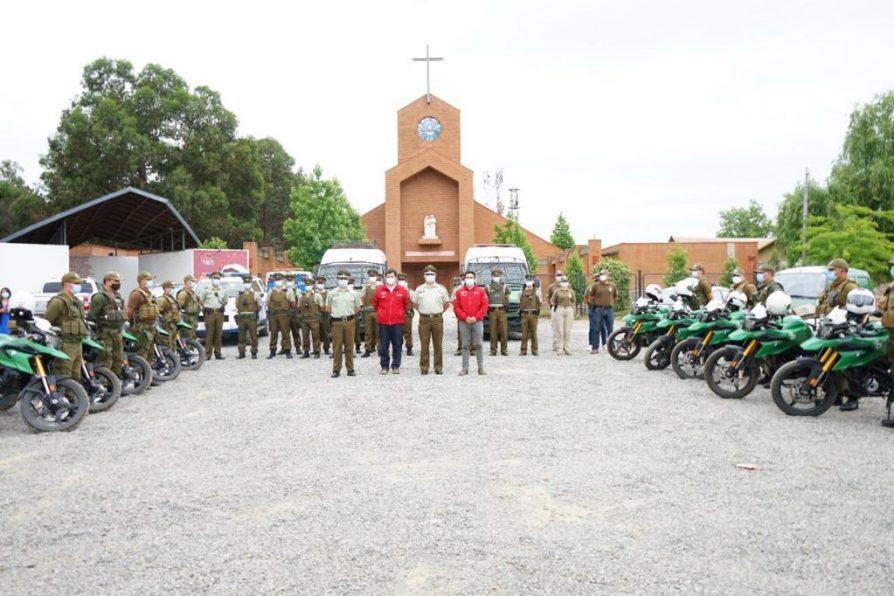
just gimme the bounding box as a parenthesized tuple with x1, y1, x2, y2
(0, 242, 68, 295)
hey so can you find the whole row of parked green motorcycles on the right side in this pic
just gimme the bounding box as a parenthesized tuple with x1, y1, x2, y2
(608, 280, 894, 426)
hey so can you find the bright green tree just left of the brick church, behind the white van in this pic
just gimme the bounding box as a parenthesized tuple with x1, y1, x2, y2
(283, 166, 366, 269)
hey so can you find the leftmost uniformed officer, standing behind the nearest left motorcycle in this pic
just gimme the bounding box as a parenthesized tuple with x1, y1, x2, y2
(46, 271, 87, 383)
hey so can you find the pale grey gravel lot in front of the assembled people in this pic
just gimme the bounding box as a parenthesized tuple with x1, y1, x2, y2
(0, 320, 894, 594)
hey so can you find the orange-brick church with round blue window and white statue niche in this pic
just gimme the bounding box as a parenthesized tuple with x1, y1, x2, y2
(362, 96, 562, 285)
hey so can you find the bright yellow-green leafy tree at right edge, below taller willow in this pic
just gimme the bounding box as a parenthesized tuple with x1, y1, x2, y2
(807, 205, 894, 281)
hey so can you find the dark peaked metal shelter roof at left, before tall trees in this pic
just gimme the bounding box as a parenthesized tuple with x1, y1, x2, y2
(0, 186, 199, 252)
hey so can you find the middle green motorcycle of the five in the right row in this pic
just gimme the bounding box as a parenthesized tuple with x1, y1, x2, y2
(670, 301, 745, 379)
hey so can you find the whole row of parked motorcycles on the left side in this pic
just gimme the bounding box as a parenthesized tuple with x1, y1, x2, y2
(0, 308, 205, 432)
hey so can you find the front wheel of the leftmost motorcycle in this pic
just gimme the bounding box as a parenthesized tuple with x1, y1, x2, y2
(20, 377, 90, 432)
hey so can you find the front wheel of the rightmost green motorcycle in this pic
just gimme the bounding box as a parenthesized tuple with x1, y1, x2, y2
(770, 358, 838, 416)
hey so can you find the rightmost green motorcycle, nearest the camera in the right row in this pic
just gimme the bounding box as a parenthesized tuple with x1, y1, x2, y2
(770, 308, 892, 422)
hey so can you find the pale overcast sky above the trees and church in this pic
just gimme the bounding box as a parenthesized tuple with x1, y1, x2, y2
(0, 0, 894, 245)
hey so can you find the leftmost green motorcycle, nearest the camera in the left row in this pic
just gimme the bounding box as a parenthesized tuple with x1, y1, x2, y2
(0, 309, 90, 432)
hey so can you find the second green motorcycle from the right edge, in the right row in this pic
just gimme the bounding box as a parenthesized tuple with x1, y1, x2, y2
(705, 304, 813, 399)
